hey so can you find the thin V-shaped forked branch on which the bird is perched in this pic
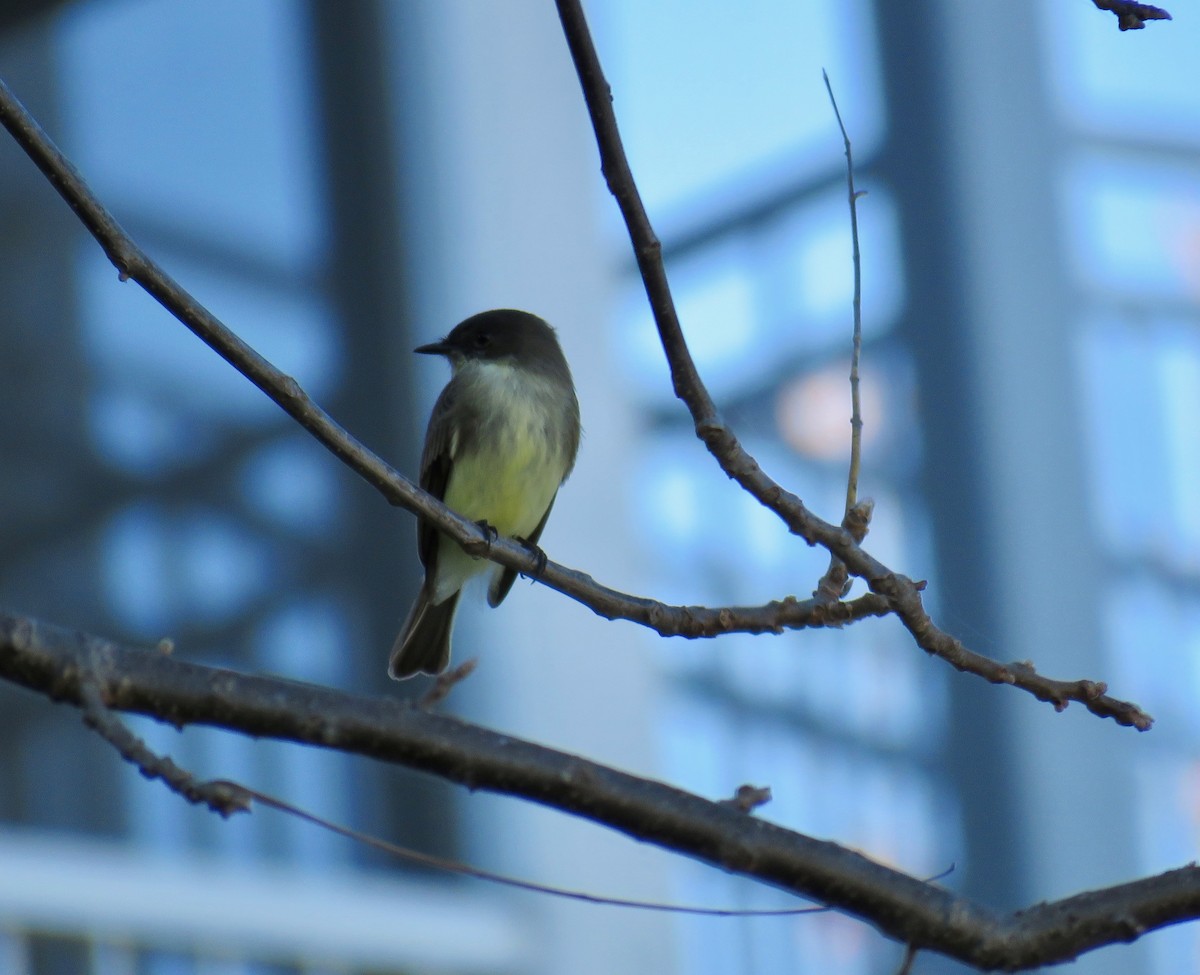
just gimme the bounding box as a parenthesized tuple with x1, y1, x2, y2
(0, 62, 1153, 730)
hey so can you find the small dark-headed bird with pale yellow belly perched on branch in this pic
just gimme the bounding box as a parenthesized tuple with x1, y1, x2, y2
(388, 309, 580, 681)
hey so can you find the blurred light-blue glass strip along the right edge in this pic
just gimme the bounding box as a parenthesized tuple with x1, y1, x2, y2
(1043, 4, 1200, 973)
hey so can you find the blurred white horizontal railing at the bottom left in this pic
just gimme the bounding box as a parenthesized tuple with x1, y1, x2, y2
(0, 830, 534, 975)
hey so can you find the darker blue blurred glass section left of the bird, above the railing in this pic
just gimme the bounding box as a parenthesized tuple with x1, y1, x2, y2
(54, 2, 355, 862)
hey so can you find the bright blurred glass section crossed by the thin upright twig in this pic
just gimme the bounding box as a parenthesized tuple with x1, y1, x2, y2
(596, 2, 958, 974)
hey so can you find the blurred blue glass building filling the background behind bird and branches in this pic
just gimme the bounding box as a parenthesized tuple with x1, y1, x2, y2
(0, 0, 1200, 975)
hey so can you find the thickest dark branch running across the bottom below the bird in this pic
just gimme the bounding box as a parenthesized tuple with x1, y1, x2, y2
(0, 615, 1200, 970)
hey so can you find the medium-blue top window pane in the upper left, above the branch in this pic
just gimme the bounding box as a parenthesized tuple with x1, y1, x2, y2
(59, 0, 320, 265)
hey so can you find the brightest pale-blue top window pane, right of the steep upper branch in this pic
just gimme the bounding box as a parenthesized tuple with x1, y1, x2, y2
(593, 0, 882, 220)
